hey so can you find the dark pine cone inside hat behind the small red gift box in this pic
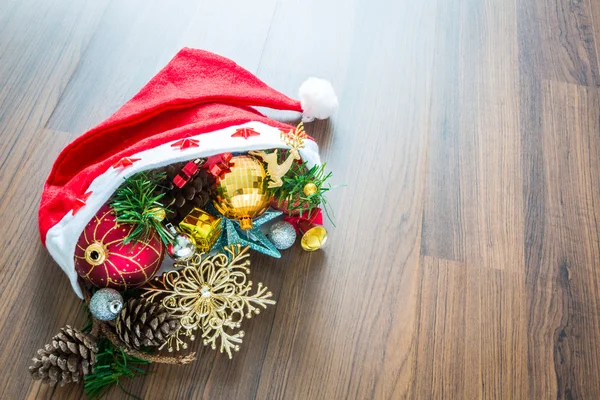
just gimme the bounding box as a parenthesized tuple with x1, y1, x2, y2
(162, 163, 214, 225)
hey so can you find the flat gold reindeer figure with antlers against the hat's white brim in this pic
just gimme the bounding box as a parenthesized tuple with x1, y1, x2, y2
(249, 122, 307, 188)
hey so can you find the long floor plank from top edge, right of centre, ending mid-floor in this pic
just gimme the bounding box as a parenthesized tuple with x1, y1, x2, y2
(423, 0, 523, 271)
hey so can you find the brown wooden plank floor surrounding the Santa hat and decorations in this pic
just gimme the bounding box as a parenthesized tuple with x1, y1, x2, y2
(0, 0, 600, 399)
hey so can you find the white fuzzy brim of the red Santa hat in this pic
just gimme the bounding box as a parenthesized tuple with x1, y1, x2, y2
(46, 122, 321, 298)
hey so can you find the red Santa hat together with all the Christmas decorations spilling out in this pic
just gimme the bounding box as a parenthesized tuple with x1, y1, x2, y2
(30, 49, 337, 397)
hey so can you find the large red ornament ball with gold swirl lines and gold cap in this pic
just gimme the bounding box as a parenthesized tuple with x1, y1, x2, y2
(75, 205, 166, 290)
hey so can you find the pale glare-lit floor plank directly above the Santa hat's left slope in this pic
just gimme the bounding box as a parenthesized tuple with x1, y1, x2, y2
(48, 0, 275, 132)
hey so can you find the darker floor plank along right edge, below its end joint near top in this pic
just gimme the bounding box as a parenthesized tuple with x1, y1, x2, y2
(526, 81, 600, 398)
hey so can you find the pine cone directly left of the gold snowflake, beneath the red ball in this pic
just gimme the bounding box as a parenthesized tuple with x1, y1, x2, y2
(115, 298, 179, 350)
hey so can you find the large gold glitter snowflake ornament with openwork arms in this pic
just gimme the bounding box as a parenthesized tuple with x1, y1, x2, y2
(142, 245, 275, 358)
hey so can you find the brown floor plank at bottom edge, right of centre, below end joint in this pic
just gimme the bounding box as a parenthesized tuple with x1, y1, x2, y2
(414, 256, 527, 399)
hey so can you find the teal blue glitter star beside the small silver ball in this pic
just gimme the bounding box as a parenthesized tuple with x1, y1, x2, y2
(213, 211, 282, 258)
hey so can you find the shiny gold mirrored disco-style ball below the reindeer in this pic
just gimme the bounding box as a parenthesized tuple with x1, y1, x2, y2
(213, 156, 270, 230)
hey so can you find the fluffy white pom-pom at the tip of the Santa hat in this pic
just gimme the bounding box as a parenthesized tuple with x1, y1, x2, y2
(298, 78, 338, 122)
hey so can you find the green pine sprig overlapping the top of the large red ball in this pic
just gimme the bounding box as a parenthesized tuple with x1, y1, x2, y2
(110, 172, 173, 244)
